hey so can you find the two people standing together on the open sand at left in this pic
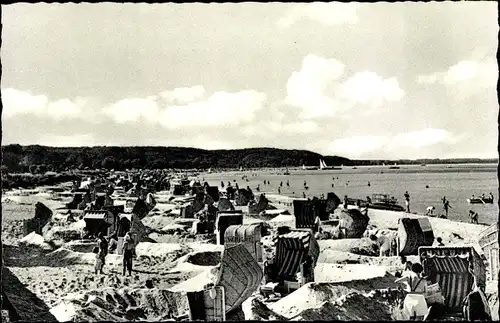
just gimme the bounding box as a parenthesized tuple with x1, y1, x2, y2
(93, 231, 135, 276)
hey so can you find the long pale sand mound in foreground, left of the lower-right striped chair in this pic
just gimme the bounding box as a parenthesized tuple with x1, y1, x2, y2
(270, 276, 398, 318)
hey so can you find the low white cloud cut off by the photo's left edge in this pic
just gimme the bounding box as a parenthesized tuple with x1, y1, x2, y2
(2, 88, 86, 121)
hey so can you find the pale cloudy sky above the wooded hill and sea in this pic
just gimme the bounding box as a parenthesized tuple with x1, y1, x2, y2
(1, 2, 499, 159)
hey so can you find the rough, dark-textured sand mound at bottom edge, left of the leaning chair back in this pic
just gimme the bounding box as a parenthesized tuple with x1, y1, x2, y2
(51, 289, 188, 322)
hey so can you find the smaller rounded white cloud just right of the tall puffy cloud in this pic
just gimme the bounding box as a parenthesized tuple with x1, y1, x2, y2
(340, 72, 405, 106)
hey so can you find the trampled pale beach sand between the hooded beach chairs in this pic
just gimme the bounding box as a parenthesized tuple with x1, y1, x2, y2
(2, 184, 498, 320)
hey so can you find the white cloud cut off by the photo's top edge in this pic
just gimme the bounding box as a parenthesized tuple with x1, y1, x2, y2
(277, 2, 359, 28)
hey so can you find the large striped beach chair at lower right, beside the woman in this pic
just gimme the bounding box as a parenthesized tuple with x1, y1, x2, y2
(418, 247, 486, 314)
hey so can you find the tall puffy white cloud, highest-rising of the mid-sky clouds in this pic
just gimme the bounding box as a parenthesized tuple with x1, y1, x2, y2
(285, 55, 344, 118)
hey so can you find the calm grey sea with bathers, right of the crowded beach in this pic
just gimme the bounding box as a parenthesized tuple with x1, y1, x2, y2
(202, 164, 498, 224)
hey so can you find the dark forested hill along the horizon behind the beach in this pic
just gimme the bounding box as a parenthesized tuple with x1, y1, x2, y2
(2, 145, 352, 172)
